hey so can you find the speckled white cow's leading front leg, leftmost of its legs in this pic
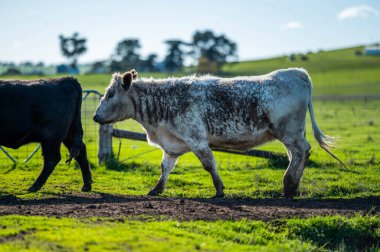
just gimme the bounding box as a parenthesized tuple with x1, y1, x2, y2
(148, 152, 178, 196)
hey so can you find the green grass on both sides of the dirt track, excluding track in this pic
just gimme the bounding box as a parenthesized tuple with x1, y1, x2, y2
(0, 48, 380, 251)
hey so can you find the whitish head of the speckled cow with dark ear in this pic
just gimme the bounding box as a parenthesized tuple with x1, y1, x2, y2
(93, 70, 137, 124)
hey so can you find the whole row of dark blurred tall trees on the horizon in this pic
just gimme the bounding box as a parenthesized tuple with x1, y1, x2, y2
(59, 30, 237, 73)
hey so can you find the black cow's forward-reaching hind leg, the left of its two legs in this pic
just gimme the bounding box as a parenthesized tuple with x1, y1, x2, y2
(28, 143, 61, 192)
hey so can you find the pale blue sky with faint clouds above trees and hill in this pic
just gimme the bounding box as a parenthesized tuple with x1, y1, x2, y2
(0, 0, 380, 64)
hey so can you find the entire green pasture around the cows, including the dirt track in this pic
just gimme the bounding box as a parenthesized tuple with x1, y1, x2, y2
(0, 48, 380, 251)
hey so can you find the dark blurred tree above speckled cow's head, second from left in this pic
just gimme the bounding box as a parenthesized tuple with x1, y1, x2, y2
(111, 39, 141, 71)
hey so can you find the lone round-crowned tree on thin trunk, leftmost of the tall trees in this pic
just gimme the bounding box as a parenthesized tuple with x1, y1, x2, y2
(59, 32, 87, 68)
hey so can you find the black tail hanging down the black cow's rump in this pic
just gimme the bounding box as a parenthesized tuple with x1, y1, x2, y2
(66, 79, 83, 163)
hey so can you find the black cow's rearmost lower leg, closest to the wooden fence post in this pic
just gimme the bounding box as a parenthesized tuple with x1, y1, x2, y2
(63, 140, 92, 192)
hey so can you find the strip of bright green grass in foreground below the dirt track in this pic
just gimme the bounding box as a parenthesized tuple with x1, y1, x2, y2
(0, 216, 380, 251)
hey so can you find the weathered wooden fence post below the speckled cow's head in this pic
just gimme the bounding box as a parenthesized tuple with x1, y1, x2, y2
(98, 124, 113, 165)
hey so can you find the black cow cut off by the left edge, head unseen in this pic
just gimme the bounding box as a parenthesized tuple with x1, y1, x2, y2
(0, 77, 92, 192)
